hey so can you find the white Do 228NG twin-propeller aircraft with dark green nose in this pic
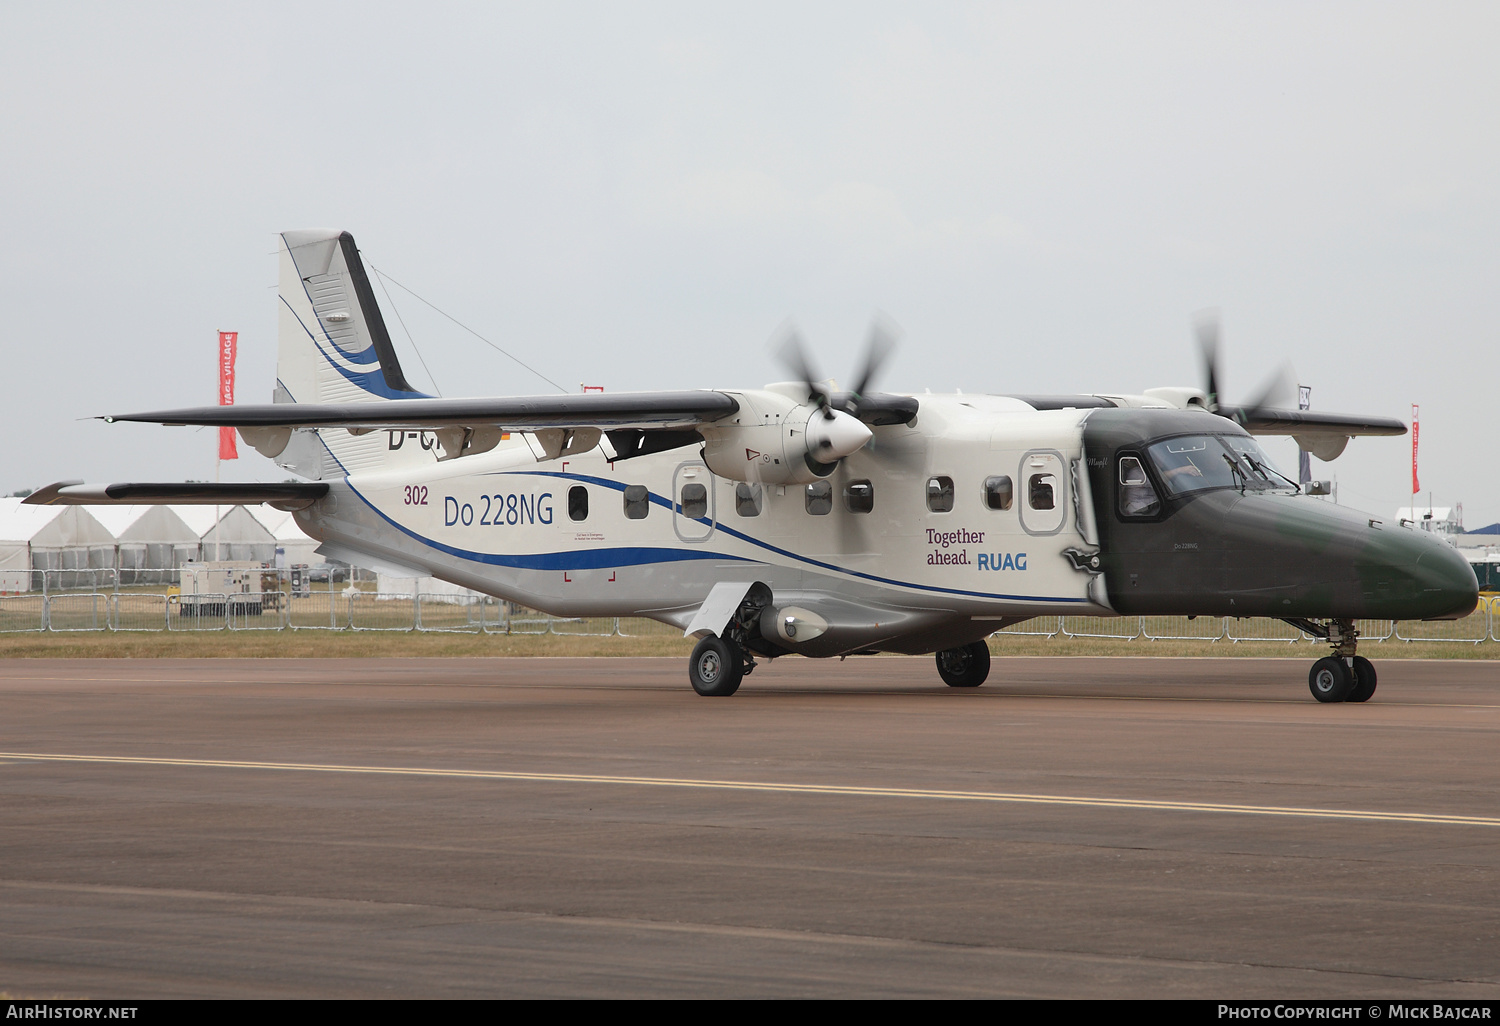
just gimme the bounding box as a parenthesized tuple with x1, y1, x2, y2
(27, 230, 1478, 702)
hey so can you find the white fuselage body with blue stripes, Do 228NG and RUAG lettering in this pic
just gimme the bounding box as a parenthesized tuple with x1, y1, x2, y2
(299, 396, 1109, 644)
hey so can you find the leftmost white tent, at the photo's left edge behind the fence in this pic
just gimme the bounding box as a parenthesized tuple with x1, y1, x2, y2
(0, 497, 114, 591)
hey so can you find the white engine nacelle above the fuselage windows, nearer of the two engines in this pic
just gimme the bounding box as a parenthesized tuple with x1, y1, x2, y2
(698, 390, 872, 485)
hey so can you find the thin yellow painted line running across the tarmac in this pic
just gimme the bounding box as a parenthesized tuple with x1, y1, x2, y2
(0, 752, 1500, 827)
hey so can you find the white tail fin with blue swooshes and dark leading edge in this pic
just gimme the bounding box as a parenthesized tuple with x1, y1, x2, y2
(273, 228, 426, 479)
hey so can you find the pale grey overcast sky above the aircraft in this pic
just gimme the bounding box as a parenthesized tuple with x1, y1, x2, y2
(0, 0, 1500, 528)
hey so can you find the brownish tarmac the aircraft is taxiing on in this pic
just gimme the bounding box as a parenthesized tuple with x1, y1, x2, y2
(0, 657, 1500, 999)
